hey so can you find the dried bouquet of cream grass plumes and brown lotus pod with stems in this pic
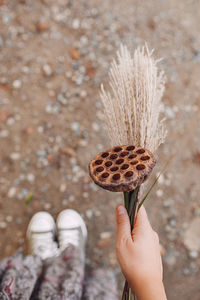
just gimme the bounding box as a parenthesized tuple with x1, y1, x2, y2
(89, 45, 166, 300)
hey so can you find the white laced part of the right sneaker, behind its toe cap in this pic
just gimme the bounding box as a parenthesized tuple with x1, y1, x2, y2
(58, 227, 80, 250)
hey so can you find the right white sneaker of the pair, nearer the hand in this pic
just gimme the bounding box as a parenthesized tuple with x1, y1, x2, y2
(56, 209, 87, 251)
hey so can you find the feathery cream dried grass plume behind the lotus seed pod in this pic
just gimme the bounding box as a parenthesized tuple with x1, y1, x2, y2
(100, 45, 166, 152)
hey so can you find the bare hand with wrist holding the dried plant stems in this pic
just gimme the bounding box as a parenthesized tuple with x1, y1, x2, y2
(116, 205, 166, 300)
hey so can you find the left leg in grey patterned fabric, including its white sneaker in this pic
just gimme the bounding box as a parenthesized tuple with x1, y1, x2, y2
(0, 212, 57, 300)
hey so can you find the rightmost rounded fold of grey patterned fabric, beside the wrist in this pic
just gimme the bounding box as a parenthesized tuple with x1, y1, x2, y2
(83, 269, 118, 300)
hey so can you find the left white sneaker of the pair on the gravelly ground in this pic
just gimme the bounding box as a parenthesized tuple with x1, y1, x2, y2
(26, 211, 59, 259)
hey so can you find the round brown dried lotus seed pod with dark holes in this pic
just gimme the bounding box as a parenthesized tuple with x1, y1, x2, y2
(89, 145, 156, 192)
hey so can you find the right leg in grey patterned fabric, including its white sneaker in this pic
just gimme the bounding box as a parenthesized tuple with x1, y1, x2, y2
(39, 209, 87, 300)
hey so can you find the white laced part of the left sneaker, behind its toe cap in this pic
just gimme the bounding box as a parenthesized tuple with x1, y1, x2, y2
(31, 232, 58, 256)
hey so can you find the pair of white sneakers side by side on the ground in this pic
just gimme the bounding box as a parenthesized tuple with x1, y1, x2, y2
(26, 209, 87, 259)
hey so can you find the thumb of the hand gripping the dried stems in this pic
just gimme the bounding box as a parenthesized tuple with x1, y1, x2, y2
(116, 205, 131, 245)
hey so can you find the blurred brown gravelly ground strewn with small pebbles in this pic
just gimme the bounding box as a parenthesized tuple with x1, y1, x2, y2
(0, 0, 200, 300)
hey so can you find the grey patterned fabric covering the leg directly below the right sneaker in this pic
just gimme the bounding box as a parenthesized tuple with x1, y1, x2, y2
(38, 245, 84, 300)
